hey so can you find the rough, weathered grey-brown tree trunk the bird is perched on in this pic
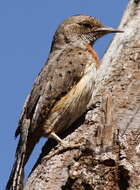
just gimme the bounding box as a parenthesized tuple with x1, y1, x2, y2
(24, 0, 140, 190)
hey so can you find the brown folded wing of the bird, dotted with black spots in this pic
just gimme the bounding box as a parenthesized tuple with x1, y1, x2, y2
(16, 48, 88, 136)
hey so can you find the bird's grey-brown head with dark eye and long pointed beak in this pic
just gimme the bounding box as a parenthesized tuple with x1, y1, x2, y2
(50, 15, 122, 48)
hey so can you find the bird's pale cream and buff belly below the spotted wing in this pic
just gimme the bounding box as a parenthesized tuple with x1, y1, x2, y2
(43, 64, 96, 135)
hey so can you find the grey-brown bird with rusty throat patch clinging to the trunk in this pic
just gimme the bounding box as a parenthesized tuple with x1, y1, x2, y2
(6, 14, 122, 190)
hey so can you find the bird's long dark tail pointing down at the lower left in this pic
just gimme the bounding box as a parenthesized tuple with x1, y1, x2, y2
(5, 120, 39, 190)
